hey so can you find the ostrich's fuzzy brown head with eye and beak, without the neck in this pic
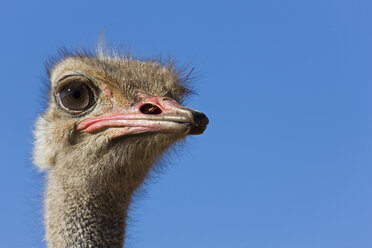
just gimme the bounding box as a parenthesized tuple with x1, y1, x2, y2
(34, 49, 208, 192)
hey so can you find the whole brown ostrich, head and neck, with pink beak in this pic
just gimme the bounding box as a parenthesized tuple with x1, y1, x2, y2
(34, 47, 208, 248)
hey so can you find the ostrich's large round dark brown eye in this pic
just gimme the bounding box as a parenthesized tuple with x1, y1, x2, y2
(58, 81, 95, 113)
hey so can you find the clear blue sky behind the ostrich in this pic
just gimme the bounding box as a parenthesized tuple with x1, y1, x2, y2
(0, 0, 372, 248)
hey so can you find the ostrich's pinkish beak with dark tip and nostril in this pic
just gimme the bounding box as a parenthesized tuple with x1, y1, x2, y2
(77, 94, 209, 137)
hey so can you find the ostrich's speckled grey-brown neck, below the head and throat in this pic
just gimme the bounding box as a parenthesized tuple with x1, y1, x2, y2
(45, 165, 139, 248)
